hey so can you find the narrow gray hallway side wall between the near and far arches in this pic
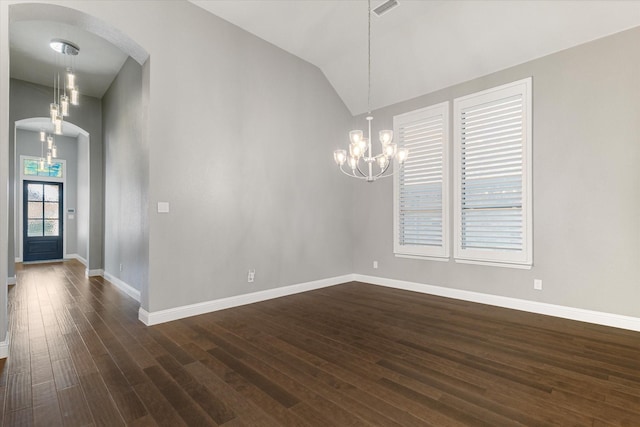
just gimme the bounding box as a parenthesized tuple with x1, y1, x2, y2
(102, 58, 149, 290)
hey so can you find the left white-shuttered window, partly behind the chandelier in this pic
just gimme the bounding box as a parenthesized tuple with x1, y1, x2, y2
(393, 102, 449, 259)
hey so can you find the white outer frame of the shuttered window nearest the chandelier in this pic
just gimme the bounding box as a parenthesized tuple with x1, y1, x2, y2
(393, 101, 450, 261)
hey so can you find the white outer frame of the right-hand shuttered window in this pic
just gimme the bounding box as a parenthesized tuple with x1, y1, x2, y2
(453, 77, 533, 269)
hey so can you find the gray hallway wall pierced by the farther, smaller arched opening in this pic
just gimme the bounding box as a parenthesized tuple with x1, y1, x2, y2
(8, 79, 103, 276)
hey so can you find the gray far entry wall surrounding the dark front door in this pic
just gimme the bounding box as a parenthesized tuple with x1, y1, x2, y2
(14, 129, 78, 257)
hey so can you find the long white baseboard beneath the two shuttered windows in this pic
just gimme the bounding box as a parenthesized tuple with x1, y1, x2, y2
(352, 274, 640, 332)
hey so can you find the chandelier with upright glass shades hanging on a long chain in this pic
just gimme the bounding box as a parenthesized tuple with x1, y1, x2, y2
(333, 0, 409, 182)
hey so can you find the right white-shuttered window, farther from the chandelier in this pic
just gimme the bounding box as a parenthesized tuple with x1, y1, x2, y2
(453, 78, 532, 268)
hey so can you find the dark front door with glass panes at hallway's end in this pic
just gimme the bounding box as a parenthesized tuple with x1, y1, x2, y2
(22, 181, 63, 261)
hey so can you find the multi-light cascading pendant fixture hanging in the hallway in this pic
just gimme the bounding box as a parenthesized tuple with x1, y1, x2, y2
(39, 39, 80, 169)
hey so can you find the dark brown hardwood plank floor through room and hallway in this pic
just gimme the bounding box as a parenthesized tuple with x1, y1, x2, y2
(0, 261, 640, 426)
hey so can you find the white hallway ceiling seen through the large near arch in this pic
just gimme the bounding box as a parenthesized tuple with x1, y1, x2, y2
(9, 20, 127, 98)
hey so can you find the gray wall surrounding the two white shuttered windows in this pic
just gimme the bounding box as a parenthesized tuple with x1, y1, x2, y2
(354, 28, 640, 316)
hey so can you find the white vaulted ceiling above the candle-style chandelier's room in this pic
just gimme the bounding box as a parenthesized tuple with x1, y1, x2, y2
(189, 0, 640, 114)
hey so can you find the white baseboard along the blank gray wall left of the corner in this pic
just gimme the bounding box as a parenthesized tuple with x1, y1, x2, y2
(138, 274, 354, 326)
